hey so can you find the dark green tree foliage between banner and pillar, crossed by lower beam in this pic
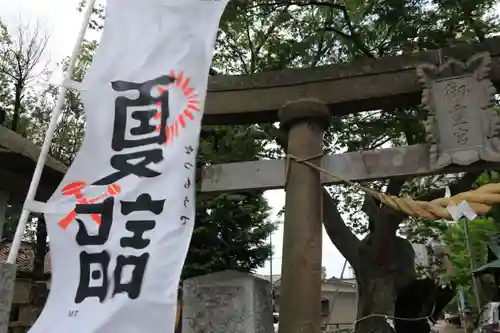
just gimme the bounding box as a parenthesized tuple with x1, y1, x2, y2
(183, 126, 275, 278)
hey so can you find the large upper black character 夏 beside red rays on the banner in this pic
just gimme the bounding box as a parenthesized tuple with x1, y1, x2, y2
(93, 75, 175, 185)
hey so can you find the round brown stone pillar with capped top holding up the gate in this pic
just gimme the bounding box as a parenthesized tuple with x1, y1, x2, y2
(279, 99, 331, 333)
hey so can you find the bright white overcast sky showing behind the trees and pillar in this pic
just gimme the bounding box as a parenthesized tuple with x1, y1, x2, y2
(0, 0, 352, 277)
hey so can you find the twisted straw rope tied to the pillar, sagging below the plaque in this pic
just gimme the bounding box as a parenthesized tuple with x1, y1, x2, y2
(285, 154, 500, 221)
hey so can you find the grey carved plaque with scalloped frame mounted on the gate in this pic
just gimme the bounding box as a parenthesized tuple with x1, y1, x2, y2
(417, 53, 500, 168)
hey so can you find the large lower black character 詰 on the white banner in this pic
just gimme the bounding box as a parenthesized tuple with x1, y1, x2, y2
(75, 193, 165, 304)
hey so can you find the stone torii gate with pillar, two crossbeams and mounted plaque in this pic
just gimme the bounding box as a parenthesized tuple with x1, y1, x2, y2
(198, 38, 500, 333)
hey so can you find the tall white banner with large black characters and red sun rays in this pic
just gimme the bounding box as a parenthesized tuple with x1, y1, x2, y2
(33, 0, 228, 333)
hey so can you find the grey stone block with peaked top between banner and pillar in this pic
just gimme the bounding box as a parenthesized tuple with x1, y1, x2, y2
(182, 271, 274, 333)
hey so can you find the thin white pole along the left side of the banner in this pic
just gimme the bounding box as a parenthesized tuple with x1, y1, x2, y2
(7, 0, 95, 264)
